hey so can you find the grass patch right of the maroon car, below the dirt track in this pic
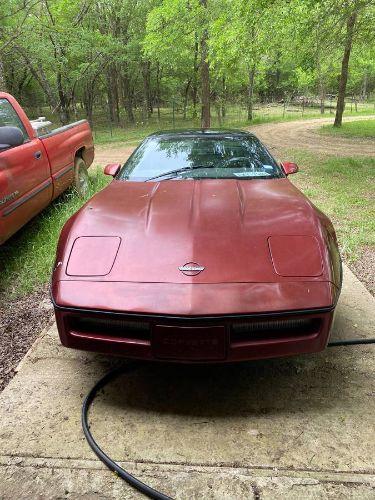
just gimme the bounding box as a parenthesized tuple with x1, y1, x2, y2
(290, 150, 375, 262)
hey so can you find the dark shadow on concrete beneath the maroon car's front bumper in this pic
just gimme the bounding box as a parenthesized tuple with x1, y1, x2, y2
(96, 347, 355, 418)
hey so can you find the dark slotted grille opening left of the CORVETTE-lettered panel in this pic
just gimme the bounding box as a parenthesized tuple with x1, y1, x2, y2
(69, 316, 150, 340)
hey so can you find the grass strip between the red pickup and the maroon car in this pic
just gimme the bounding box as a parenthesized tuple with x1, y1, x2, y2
(0, 170, 109, 301)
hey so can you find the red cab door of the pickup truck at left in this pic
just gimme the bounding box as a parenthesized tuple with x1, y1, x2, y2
(0, 98, 53, 244)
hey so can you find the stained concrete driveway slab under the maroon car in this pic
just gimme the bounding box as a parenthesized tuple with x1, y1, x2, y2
(0, 268, 375, 499)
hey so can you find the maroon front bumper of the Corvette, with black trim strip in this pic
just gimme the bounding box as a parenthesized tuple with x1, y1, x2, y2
(52, 281, 338, 363)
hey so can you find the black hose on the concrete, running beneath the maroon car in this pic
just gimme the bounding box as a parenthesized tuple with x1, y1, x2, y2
(82, 338, 375, 500)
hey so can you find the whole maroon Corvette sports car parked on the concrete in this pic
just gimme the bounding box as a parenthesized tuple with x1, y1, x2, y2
(52, 130, 342, 362)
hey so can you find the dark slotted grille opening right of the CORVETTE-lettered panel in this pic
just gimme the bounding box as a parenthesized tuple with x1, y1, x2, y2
(231, 318, 321, 342)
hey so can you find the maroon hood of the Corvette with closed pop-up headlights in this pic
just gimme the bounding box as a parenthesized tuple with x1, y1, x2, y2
(58, 178, 329, 284)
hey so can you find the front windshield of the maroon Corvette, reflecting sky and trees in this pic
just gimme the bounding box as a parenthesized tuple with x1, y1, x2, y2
(117, 135, 283, 181)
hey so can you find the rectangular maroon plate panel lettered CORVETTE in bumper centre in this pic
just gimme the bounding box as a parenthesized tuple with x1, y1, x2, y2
(151, 325, 227, 361)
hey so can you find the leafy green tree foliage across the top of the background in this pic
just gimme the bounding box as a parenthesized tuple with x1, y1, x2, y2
(0, 0, 375, 126)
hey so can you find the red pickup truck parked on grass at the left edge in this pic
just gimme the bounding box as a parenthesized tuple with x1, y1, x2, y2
(0, 92, 94, 245)
